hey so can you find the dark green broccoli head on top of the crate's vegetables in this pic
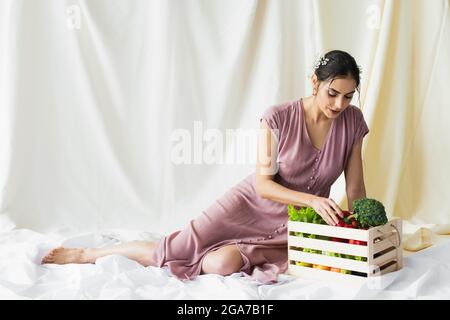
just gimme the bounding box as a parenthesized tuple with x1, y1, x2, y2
(347, 198, 388, 228)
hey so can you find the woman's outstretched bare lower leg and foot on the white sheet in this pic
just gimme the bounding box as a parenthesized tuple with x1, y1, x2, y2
(41, 241, 158, 267)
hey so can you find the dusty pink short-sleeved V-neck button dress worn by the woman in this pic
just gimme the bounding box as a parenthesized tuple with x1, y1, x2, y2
(153, 99, 369, 283)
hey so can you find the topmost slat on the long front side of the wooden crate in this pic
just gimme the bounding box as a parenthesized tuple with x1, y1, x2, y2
(288, 221, 369, 241)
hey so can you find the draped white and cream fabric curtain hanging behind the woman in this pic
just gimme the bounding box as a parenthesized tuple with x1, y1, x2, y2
(0, 0, 450, 233)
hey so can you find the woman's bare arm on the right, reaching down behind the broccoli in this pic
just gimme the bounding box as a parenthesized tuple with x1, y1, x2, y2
(345, 139, 366, 211)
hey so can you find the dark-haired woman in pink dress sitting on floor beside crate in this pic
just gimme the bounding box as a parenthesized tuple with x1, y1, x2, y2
(42, 50, 369, 283)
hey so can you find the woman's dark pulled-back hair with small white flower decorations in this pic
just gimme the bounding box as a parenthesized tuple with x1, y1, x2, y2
(314, 50, 361, 105)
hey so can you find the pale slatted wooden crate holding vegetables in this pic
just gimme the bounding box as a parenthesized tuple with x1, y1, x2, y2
(288, 219, 403, 283)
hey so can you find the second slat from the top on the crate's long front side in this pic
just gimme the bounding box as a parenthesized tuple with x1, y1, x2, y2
(288, 236, 367, 257)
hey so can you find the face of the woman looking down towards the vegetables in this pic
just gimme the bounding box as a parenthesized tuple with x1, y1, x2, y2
(316, 77, 356, 119)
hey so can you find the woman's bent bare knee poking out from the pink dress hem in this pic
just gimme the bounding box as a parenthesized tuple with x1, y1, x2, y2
(201, 244, 244, 276)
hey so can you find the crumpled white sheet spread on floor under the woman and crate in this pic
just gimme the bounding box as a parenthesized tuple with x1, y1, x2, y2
(0, 229, 450, 300)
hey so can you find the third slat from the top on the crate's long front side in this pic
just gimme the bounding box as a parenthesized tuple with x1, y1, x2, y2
(288, 250, 369, 273)
